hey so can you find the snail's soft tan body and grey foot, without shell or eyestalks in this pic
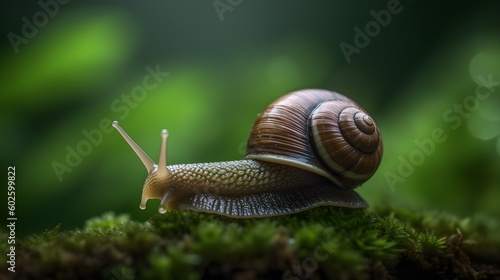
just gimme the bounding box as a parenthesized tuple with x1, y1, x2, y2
(141, 160, 367, 218)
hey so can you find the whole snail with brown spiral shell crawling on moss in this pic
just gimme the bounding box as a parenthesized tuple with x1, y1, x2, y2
(113, 89, 383, 218)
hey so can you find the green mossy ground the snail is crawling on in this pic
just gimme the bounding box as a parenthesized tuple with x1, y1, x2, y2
(0, 208, 500, 279)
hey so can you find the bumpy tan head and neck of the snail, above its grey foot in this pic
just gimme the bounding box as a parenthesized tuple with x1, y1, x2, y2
(141, 160, 322, 206)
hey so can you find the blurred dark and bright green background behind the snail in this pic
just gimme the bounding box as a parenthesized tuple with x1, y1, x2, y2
(0, 0, 500, 236)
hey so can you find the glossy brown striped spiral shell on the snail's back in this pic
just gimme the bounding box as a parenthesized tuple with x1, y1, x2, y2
(246, 89, 383, 188)
